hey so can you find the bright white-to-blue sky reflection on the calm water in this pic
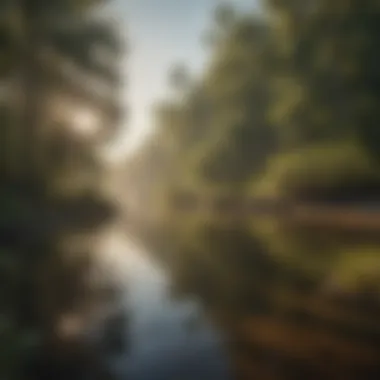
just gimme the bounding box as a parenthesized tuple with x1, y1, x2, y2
(95, 229, 230, 380)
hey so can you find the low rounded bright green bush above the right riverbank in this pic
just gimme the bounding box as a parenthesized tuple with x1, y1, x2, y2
(251, 142, 380, 199)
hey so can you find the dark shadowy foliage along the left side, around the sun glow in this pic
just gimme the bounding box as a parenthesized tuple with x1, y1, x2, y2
(0, 0, 122, 380)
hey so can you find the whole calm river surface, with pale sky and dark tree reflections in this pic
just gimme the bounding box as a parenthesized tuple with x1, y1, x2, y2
(90, 219, 380, 380)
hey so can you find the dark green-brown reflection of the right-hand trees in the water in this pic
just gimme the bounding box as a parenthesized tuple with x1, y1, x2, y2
(158, 218, 380, 379)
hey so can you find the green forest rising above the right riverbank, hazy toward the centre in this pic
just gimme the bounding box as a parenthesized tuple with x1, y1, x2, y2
(126, 0, 380, 220)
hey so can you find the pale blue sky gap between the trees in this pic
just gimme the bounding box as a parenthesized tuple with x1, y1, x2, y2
(107, 0, 257, 159)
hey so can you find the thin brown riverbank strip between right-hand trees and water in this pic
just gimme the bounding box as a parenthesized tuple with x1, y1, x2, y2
(164, 199, 380, 232)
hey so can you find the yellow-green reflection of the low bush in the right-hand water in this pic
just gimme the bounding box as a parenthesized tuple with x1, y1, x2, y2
(251, 217, 380, 294)
